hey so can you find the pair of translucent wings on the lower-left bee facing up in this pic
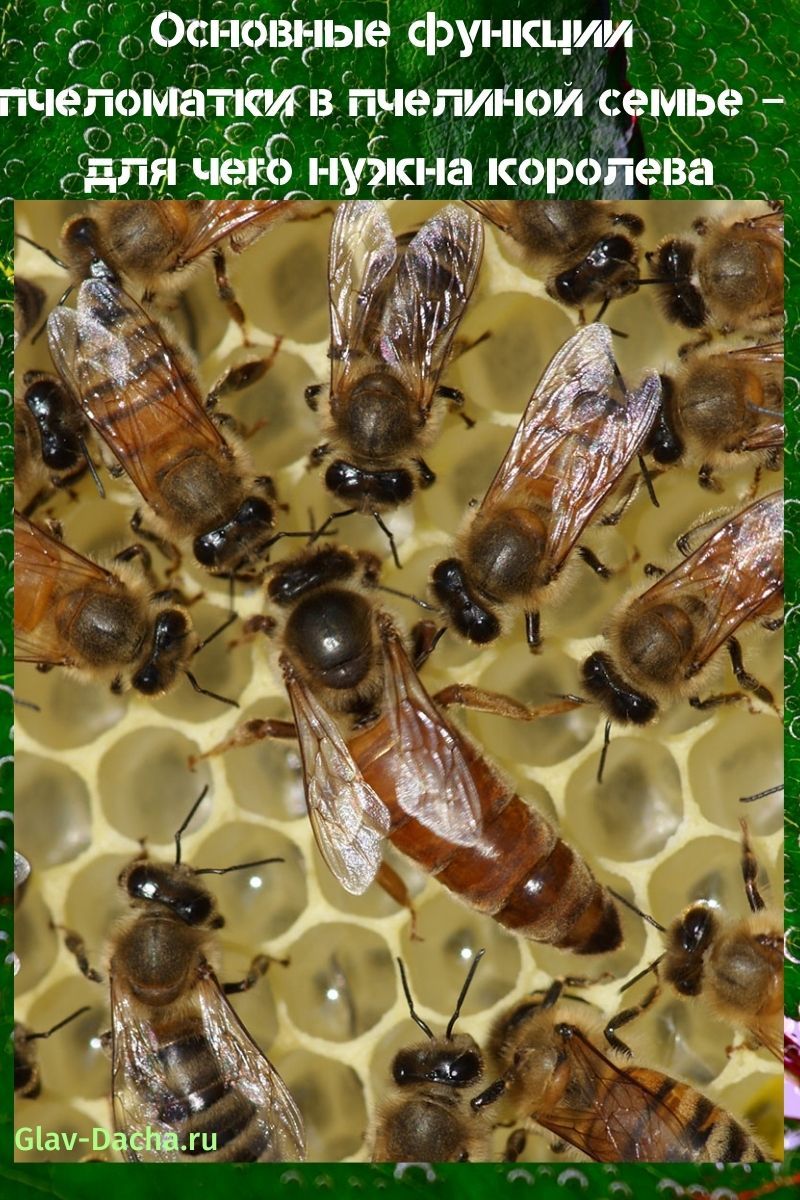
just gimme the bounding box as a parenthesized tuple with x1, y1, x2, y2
(112, 961, 306, 1163)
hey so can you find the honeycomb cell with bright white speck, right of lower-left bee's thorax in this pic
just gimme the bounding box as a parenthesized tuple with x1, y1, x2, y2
(273, 922, 397, 1042)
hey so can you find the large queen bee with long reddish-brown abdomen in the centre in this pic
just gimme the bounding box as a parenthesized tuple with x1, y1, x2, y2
(196, 546, 622, 954)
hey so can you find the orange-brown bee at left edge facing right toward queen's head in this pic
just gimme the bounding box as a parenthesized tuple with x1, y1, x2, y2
(14, 512, 227, 703)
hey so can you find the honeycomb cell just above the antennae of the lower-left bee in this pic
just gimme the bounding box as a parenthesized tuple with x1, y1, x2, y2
(97, 726, 213, 845)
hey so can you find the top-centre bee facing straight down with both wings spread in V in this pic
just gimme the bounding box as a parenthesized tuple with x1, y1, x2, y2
(306, 200, 483, 561)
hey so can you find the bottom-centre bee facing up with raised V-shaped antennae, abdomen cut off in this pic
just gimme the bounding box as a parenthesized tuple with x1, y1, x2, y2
(372, 950, 491, 1163)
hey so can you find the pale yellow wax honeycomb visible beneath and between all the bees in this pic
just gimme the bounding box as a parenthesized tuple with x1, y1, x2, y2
(16, 200, 782, 1162)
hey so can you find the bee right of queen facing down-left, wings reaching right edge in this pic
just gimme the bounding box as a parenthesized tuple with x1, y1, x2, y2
(582, 492, 783, 725)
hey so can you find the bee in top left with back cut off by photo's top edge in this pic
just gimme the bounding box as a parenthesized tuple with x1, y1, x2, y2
(53, 200, 321, 325)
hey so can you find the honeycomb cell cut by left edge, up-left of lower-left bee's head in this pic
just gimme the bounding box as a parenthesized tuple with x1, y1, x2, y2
(14, 754, 91, 869)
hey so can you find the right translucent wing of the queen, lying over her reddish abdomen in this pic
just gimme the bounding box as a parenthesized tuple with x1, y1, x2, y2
(383, 626, 483, 846)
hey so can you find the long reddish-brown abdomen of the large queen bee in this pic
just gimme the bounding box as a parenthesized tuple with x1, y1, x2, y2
(349, 718, 622, 954)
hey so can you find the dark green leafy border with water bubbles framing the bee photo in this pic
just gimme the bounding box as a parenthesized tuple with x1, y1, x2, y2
(0, 0, 800, 1200)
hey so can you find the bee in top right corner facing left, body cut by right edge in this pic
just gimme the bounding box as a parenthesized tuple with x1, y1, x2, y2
(646, 206, 783, 337)
